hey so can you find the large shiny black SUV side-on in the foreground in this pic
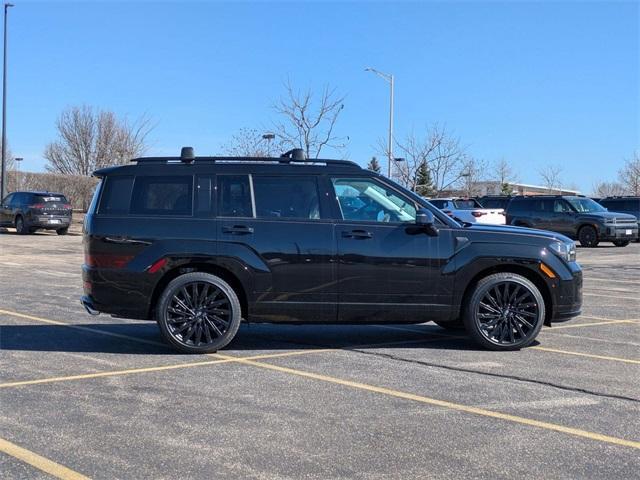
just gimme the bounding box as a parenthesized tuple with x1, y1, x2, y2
(82, 149, 582, 353)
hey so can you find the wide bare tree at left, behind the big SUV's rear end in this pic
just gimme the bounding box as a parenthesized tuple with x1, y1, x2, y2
(44, 105, 152, 175)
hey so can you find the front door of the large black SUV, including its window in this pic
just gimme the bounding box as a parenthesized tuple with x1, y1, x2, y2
(332, 177, 454, 323)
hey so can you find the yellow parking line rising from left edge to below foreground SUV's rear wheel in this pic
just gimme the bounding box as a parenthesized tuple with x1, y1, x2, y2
(0, 349, 333, 388)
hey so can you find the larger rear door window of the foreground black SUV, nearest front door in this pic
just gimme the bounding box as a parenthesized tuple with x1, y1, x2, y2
(253, 176, 320, 219)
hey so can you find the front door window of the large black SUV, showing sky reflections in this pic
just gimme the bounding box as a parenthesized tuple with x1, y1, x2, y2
(332, 178, 416, 223)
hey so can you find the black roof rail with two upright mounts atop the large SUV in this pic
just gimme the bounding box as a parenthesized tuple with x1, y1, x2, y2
(131, 147, 361, 169)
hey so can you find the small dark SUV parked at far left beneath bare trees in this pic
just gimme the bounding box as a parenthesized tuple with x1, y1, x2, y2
(0, 192, 72, 235)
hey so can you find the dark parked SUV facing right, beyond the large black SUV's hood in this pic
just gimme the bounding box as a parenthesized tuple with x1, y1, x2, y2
(507, 195, 638, 247)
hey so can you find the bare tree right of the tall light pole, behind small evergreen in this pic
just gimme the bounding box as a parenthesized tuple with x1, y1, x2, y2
(396, 125, 468, 195)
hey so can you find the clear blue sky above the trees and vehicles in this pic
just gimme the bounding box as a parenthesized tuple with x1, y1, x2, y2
(7, 0, 640, 192)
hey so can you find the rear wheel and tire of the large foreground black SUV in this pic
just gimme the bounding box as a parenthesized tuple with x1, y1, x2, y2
(156, 272, 242, 353)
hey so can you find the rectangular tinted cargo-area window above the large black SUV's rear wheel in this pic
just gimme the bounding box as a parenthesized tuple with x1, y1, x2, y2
(131, 175, 193, 216)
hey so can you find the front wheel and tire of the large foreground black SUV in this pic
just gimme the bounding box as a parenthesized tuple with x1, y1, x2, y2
(463, 273, 545, 350)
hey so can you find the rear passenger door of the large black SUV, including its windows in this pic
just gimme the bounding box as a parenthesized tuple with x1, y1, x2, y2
(217, 174, 337, 322)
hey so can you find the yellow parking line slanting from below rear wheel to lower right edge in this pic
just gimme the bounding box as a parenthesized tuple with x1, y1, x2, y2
(215, 352, 640, 450)
